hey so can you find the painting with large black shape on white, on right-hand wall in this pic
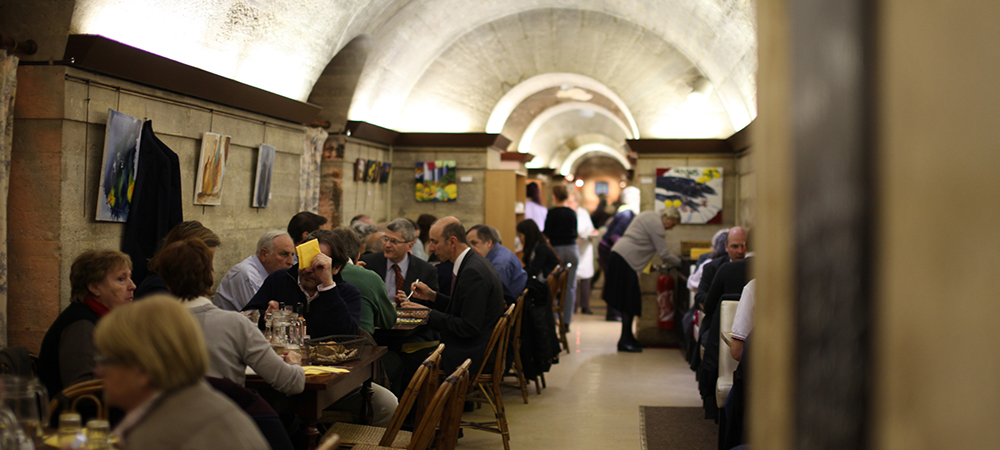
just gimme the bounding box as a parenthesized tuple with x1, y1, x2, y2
(654, 167, 722, 223)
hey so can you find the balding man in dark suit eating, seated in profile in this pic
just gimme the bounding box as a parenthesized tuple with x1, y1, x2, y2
(403, 217, 504, 373)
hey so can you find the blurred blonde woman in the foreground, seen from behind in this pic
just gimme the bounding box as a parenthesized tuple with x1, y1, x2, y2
(94, 296, 269, 450)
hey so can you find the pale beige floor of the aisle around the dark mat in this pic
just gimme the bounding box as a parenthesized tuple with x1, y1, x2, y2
(458, 300, 701, 450)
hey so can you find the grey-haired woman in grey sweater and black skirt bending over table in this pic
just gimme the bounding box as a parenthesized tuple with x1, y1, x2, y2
(604, 208, 681, 352)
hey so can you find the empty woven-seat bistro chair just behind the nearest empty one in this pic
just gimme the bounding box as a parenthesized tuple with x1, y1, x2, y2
(324, 344, 444, 448)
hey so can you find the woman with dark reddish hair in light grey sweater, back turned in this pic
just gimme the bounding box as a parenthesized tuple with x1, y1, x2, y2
(149, 239, 305, 394)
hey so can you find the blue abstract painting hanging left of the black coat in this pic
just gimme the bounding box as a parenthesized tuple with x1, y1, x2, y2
(97, 109, 142, 222)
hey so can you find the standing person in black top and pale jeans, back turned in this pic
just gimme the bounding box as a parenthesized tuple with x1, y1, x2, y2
(542, 184, 580, 330)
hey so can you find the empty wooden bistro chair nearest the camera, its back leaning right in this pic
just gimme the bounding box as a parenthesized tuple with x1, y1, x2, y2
(354, 359, 472, 450)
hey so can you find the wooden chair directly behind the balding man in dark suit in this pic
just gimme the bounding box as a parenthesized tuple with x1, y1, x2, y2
(462, 305, 516, 450)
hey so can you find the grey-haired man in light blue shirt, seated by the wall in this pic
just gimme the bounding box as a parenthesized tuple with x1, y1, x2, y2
(212, 230, 295, 311)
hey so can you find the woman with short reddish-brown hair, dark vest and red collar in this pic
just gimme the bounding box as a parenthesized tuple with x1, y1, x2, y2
(38, 250, 135, 395)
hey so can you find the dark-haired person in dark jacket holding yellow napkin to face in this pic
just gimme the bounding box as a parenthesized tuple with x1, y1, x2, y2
(243, 230, 362, 338)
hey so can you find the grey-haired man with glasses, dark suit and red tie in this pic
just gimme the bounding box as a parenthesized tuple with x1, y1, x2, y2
(361, 218, 438, 303)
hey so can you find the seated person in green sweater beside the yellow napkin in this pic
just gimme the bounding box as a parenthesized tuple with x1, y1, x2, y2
(333, 227, 396, 334)
